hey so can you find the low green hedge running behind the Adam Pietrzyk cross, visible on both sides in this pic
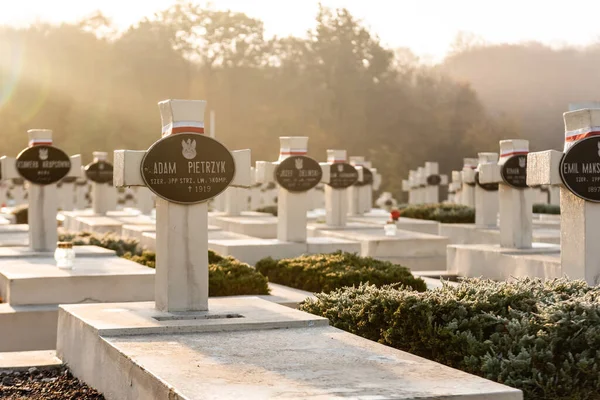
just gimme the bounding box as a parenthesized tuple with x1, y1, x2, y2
(59, 232, 269, 296)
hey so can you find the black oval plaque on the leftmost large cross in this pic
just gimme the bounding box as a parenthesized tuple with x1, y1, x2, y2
(16, 145, 71, 185)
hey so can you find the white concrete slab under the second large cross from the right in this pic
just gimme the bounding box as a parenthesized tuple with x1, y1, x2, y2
(447, 243, 562, 280)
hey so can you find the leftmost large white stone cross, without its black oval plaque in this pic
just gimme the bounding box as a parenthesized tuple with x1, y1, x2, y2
(0, 129, 81, 252)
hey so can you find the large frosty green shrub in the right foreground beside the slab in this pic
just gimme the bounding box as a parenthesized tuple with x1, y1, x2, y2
(301, 279, 600, 399)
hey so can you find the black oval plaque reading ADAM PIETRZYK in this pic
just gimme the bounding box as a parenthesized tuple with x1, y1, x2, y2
(141, 133, 235, 204)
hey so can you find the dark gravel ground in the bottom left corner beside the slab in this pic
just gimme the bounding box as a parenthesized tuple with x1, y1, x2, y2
(0, 367, 104, 400)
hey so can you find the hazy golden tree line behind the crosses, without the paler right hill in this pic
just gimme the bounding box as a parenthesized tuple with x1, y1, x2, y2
(0, 2, 520, 197)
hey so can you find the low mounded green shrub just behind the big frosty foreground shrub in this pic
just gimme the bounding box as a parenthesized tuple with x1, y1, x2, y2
(255, 252, 427, 292)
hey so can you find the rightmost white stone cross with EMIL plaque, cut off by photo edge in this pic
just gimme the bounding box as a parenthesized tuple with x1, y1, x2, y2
(527, 109, 600, 285)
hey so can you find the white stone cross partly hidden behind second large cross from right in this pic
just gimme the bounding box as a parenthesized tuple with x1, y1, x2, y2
(474, 153, 498, 228)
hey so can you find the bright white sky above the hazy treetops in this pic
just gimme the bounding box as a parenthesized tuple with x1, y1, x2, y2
(0, 0, 600, 61)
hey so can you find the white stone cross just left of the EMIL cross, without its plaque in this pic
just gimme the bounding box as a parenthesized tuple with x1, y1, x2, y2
(479, 139, 533, 249)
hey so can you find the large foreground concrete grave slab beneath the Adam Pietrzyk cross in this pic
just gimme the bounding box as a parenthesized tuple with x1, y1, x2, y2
(57, 297, 522, 400)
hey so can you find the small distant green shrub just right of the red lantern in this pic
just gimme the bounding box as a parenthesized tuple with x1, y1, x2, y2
(401, 203, 475, 224)
